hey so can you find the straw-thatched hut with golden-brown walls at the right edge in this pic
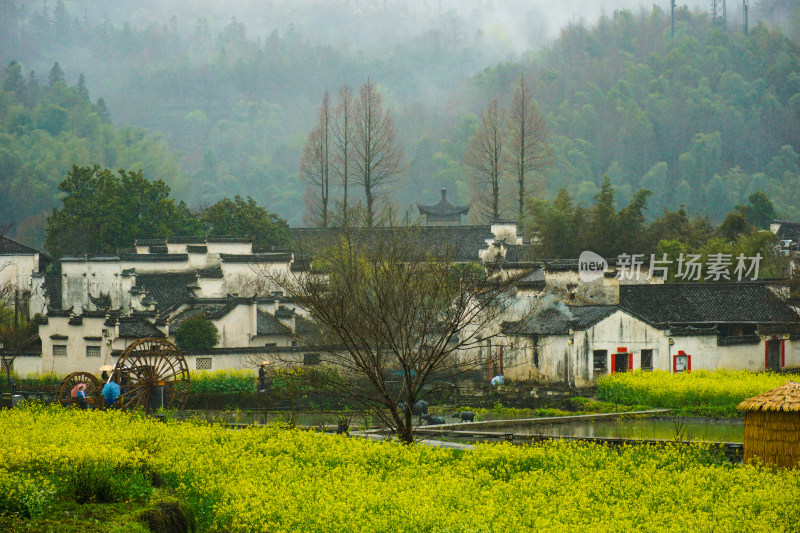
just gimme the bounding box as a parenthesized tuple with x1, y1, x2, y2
(737, 381, 800, 468)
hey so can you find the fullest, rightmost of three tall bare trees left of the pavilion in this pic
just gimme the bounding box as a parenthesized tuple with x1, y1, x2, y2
(353, 80, 403, 227)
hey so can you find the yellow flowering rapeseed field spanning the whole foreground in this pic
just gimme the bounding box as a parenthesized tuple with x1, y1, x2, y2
(0, 406, 800, 532)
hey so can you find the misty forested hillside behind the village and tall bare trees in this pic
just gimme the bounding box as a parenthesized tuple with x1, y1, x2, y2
(0, 0, 800, 245)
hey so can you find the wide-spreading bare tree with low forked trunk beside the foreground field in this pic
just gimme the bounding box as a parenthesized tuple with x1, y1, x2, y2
(266, 228, 513, 442)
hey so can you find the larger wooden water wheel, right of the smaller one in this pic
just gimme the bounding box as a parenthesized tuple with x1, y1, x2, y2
(112, 339, 189, 411)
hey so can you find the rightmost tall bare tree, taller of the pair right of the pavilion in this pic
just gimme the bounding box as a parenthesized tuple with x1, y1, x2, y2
(508, 76, 548, 220)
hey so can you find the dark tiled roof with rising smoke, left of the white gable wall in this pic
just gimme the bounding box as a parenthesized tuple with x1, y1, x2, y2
(503, 305, 617, 335)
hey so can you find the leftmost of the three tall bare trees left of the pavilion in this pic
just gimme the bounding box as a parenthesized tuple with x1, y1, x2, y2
(300, 89, 333, 228)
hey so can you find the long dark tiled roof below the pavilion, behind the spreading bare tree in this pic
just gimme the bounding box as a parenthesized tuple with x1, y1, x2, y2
(289, 225, 493, 263)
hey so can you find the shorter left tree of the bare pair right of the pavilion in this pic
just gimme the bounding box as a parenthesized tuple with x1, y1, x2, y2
(464, 98, 506, 221)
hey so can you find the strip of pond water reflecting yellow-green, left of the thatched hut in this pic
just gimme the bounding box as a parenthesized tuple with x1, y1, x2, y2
(494, 418, 744, 442)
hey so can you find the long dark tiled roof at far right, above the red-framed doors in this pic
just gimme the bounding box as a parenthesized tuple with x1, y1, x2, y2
(619, 283, 799, 326)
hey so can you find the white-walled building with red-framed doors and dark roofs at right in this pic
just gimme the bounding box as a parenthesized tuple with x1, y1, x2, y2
(494, 283, 800, 386)
